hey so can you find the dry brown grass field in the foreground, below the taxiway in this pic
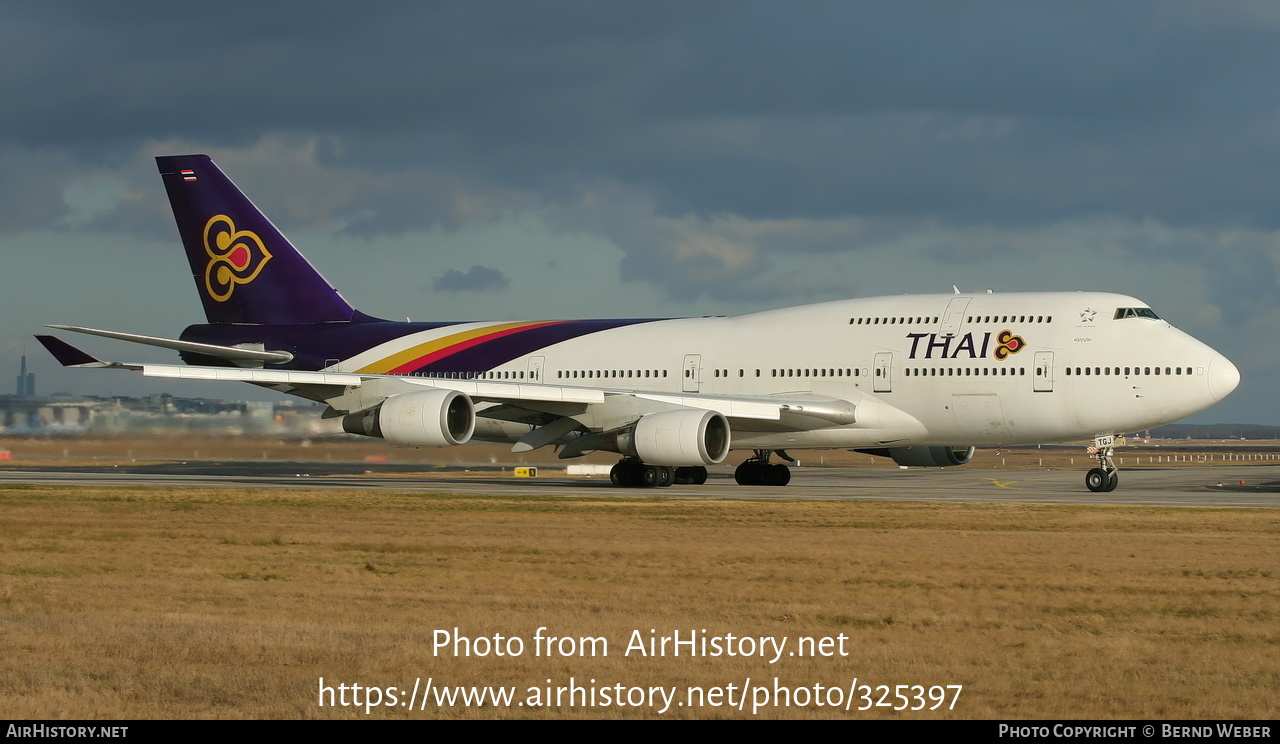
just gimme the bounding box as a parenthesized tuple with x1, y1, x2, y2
(0, 485, 1280, 720)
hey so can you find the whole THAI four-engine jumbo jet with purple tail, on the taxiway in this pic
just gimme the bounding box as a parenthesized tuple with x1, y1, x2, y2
(38, 155, 1240, 490)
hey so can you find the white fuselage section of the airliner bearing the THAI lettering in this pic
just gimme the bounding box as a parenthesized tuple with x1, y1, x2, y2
(333, 292, 1239, 449)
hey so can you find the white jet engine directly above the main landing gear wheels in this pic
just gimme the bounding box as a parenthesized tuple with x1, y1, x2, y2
(618, 408, 730, 467)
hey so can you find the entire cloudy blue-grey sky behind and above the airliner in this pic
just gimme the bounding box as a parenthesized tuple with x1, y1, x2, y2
(0, 0, 1280, 424)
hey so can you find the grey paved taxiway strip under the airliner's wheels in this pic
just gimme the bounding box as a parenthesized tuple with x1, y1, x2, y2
(0, 461, 1280, 508)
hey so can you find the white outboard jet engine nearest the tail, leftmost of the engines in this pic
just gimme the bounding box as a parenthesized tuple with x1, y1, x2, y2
(342, 391, 476, 447)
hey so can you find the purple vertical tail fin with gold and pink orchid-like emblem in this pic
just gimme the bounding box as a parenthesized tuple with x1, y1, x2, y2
(156, 155, 364, 325)
